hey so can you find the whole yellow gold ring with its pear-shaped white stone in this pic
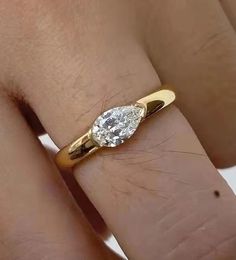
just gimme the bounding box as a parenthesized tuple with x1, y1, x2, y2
(56, 86, 175, 168)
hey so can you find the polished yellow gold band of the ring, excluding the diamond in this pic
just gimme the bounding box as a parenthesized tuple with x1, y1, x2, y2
(56, 86, 175, 168)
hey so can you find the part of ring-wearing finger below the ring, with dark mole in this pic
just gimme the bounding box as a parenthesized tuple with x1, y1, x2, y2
(75, 108, 236, 259)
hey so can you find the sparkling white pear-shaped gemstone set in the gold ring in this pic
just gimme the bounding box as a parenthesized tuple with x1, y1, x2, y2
(92, 106, 144, 147)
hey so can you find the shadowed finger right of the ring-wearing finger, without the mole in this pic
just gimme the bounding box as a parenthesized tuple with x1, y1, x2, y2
(147, 0, 236, 168)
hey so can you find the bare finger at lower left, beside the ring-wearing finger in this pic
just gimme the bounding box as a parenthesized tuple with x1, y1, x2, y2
(0, 96, 117, 260)
